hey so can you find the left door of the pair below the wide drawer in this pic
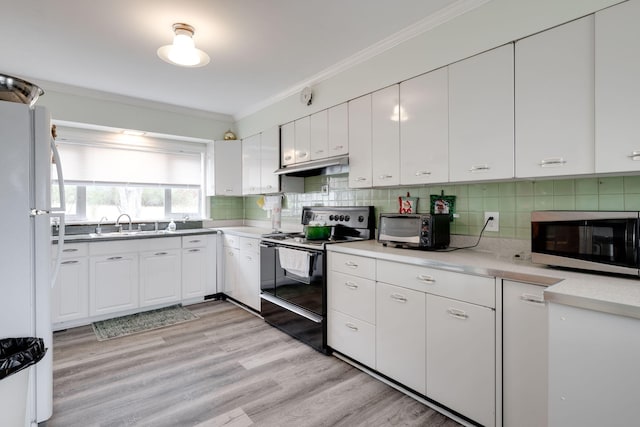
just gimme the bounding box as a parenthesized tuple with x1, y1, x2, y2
(376, 282, 426, 394)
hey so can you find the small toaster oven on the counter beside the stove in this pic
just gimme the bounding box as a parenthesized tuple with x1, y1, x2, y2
(378, 213, 450, 249)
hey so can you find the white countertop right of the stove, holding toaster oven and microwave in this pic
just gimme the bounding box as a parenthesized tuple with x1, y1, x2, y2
(327, 240, 640, 319)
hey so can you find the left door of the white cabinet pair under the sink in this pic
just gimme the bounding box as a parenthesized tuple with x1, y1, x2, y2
(89, 254, 138, 316)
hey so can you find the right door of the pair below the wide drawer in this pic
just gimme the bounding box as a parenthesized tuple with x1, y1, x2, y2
(427, 295, 496, 426)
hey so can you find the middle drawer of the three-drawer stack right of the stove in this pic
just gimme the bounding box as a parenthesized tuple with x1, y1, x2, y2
(327, 271, 376, 324)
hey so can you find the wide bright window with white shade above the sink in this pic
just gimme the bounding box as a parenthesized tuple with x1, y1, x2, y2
(51, 128, 205, 221)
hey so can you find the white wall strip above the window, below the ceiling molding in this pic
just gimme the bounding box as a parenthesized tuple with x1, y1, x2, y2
(38, 82, 234, 140)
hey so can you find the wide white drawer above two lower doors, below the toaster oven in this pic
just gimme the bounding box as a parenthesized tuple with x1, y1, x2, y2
(376, 260, 496, 308)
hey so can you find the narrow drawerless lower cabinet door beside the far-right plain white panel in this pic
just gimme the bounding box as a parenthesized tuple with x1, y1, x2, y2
(502, 280, 548, 427)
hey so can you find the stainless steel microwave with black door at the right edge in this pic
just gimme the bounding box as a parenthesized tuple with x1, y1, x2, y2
(531, 211, 640, 276)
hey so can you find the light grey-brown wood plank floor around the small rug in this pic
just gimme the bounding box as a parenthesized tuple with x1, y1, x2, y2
(46, 301, 459, 427)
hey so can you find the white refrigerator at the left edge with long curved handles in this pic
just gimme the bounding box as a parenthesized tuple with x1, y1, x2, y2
(0, 101, 64, 426)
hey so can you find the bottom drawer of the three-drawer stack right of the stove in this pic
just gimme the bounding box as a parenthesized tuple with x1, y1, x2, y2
(327, 310, 376, 368)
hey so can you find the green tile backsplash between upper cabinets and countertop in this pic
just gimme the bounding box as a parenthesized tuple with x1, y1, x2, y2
(211, 174, 640, 239)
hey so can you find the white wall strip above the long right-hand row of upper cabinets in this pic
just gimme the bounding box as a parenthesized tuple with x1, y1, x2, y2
(236, 0, 621, 137)
